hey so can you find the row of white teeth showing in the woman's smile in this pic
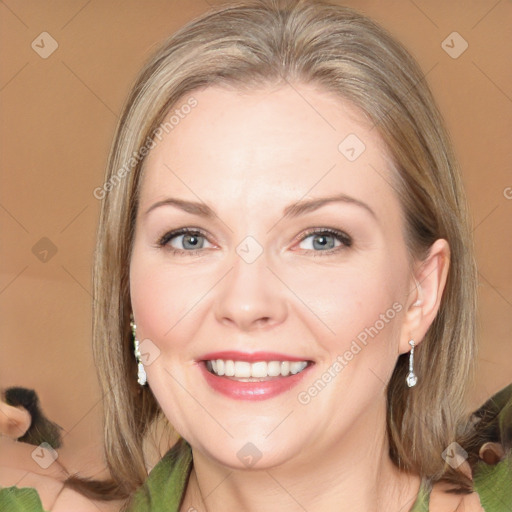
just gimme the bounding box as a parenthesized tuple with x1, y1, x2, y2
(206, 359, 308, 379)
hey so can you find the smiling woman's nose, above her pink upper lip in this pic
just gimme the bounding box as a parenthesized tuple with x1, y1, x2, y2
(214, 255, 287, 331)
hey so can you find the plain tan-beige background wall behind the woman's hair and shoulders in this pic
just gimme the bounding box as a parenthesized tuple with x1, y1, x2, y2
(0, 0, 512, 480)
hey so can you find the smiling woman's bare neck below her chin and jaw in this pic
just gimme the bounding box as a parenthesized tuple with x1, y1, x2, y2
(181, 403, 420, 512)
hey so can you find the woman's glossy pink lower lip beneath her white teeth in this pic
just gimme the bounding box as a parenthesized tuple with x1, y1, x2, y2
(199, 361, 313, 400)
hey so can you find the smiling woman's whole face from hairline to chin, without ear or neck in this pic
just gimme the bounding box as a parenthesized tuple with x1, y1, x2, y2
(130, 85, 414, 467)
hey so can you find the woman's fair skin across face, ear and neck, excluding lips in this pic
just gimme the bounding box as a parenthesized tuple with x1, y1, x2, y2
(130, 84, 449, 512)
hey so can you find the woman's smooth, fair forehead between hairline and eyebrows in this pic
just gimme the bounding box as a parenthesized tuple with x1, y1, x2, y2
(140, 85, 397, 219)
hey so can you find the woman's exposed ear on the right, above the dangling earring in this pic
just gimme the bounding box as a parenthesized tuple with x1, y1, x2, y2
(400, 239, 450, 354)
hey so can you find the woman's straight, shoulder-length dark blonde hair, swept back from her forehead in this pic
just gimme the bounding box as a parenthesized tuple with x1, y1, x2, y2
(63, 0, 476, 499)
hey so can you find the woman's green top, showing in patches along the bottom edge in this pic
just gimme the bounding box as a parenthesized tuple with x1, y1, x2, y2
(0, 384, 512, 512)
